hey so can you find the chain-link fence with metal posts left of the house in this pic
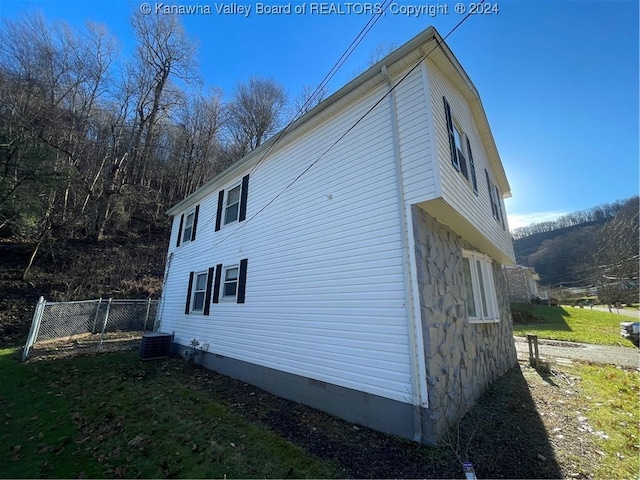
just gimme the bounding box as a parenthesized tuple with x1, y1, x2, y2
(22, 297, 158, 360)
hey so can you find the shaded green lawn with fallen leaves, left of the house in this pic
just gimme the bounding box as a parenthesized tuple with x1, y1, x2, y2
(0, 349, 338, 478)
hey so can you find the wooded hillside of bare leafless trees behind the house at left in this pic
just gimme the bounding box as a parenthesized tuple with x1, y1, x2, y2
(0, 9, 325, 338)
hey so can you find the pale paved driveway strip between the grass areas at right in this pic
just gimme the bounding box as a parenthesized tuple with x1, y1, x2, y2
(514, 337, 640, 370)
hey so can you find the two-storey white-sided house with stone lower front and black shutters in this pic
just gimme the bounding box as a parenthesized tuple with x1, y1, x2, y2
(160, 28, 516, 443)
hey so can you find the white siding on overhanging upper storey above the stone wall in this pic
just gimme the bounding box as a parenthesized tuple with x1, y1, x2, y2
(427, 60, 513, 257)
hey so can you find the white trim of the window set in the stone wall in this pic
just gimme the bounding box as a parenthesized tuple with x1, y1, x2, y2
(462, 250, 500, 323)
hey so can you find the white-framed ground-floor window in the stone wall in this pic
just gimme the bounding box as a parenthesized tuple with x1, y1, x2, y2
(462, 250, 500, 323)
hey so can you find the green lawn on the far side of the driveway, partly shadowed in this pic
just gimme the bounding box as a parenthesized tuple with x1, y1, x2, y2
(512, 304, 635, 348)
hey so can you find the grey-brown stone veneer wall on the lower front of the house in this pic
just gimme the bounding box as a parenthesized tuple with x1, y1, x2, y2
(412, 206, 516, 443)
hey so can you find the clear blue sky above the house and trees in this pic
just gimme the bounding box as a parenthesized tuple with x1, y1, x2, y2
(0, 0, 640, 228)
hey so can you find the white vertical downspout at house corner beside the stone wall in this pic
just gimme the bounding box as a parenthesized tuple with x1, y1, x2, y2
(382, 65, 428, 442)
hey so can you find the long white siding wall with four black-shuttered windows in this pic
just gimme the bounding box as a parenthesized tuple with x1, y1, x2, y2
(162, 84, 412, 402)
